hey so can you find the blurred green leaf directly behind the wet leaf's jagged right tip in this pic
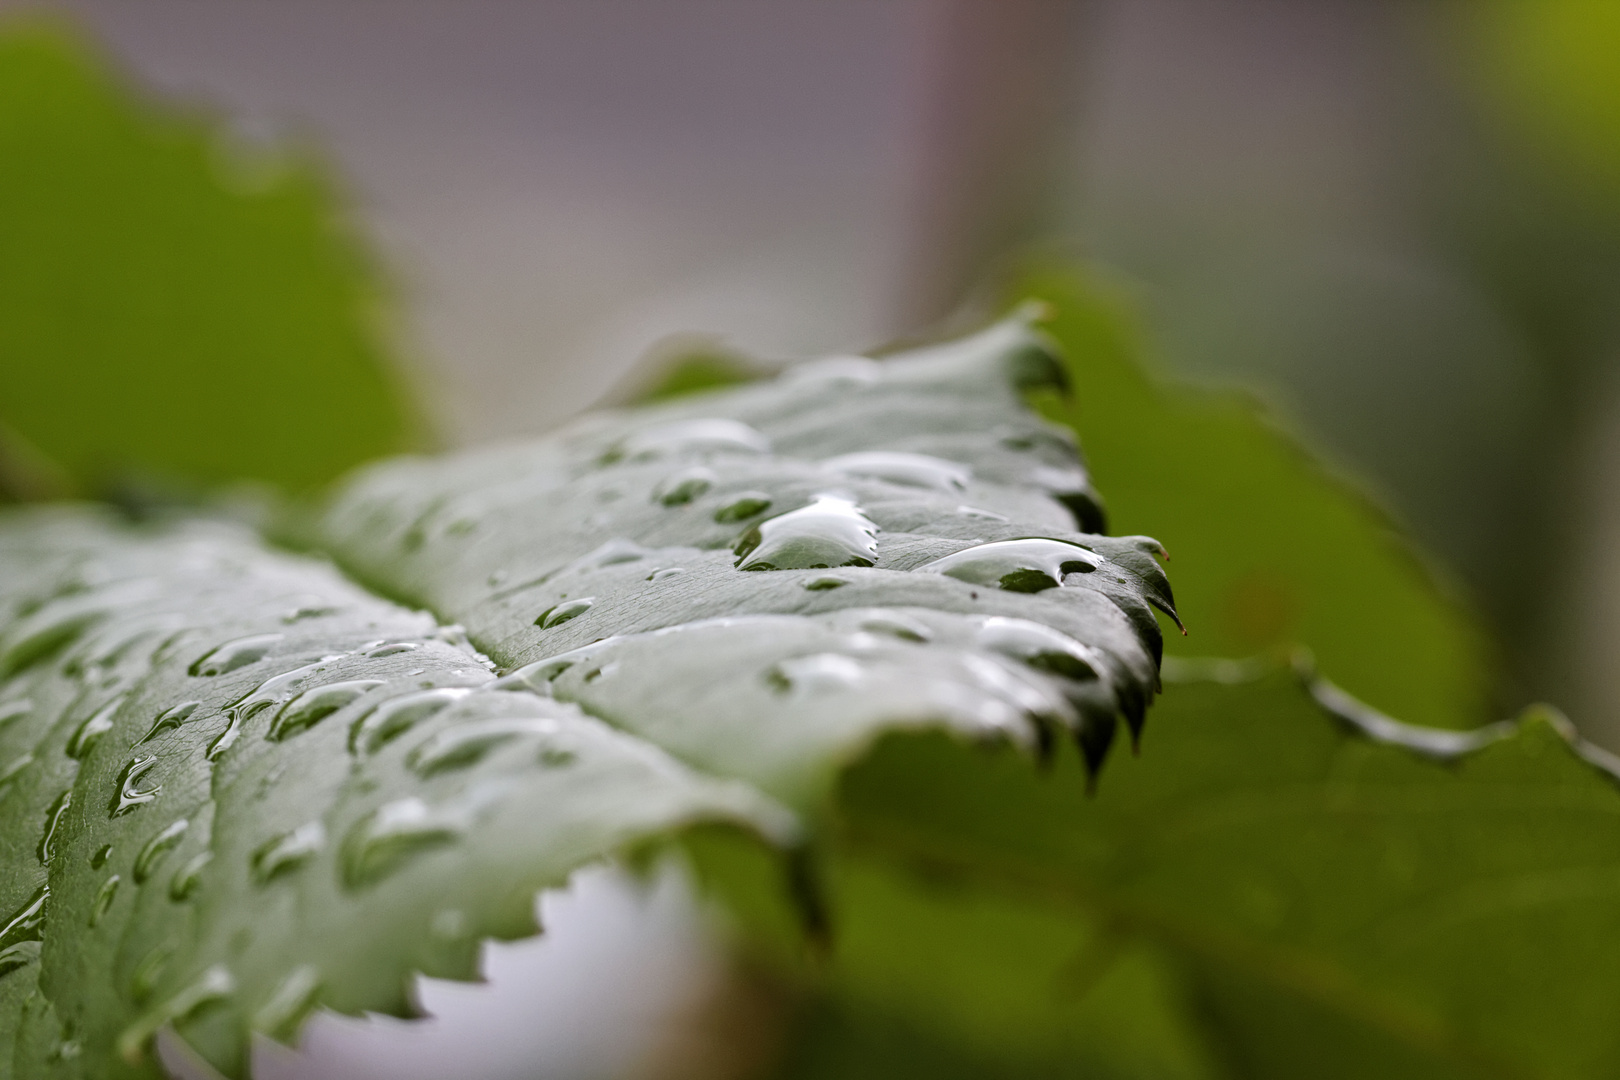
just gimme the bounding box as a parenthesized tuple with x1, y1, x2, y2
(1016, 267, 1492, 727)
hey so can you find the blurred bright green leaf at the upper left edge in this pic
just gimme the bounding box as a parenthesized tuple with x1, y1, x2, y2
(0, 23, 420, 495)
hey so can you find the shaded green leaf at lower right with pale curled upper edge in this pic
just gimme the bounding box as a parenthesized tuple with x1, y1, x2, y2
(831, 662, 1620, 1077)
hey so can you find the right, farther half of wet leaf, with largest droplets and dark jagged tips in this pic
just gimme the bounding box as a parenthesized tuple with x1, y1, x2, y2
(308, 307, 1173, 808)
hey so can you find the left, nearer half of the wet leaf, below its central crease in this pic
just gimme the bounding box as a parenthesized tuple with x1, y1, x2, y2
(0, 507, 797, 1077)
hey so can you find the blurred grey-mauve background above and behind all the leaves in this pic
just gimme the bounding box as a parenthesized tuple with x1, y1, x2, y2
(9, 0, 1620, 1075)
